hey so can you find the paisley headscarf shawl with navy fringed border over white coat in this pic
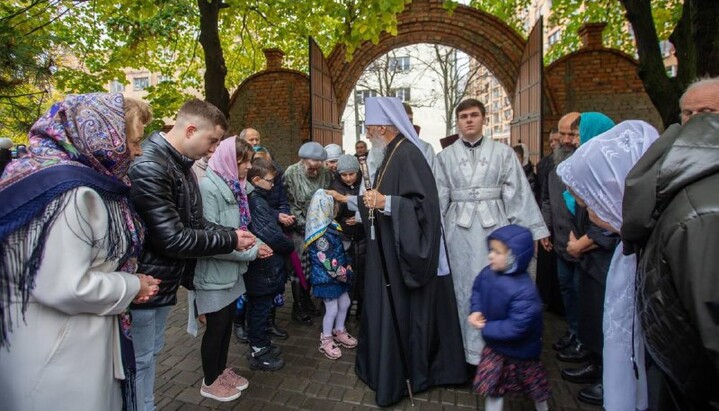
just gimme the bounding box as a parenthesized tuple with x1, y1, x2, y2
(0, 93, 144, 409)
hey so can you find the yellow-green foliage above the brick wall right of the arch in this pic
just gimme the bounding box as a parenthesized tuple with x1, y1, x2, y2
(545, 0, 682, 64)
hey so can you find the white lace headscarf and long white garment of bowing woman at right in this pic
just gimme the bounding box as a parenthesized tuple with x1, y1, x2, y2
(557, 121, 659, 411)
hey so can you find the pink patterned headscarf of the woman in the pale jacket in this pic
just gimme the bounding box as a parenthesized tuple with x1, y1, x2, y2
(208, 136, 250, 230)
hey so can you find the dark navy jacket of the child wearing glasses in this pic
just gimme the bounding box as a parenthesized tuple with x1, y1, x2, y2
(244, 187, 294, 297)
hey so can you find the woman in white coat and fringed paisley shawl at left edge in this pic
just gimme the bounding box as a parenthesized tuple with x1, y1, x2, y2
(0, 94, 158, 410)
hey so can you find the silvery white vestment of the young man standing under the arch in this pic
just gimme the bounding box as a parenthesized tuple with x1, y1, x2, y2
(435, 137, 549, 364)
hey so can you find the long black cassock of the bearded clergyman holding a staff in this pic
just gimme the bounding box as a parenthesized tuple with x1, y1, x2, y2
(355, 135, 467, 406)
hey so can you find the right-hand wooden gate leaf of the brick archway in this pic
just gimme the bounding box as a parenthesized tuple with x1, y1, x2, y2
(510, 17, 544, 164)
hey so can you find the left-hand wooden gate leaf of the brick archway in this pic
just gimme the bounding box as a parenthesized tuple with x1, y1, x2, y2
(309, 37, 342, 146)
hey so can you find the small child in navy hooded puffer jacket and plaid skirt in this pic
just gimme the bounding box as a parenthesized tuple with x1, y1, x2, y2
(468, 225, 550, 411)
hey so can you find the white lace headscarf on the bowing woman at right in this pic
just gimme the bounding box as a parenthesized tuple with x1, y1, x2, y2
(557, 120, 659, 231)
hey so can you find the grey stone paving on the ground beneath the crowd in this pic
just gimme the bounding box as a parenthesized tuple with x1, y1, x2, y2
(155, 289, 601, 411)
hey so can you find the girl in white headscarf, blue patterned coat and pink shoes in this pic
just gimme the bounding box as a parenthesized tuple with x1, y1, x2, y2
(305, 190, 357, 360)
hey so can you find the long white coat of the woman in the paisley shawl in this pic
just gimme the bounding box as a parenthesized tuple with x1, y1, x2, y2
(0, 187, 140, 411)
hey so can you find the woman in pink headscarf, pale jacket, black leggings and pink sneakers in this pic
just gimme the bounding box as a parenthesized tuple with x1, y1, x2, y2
(193, 136, 271, 401)
